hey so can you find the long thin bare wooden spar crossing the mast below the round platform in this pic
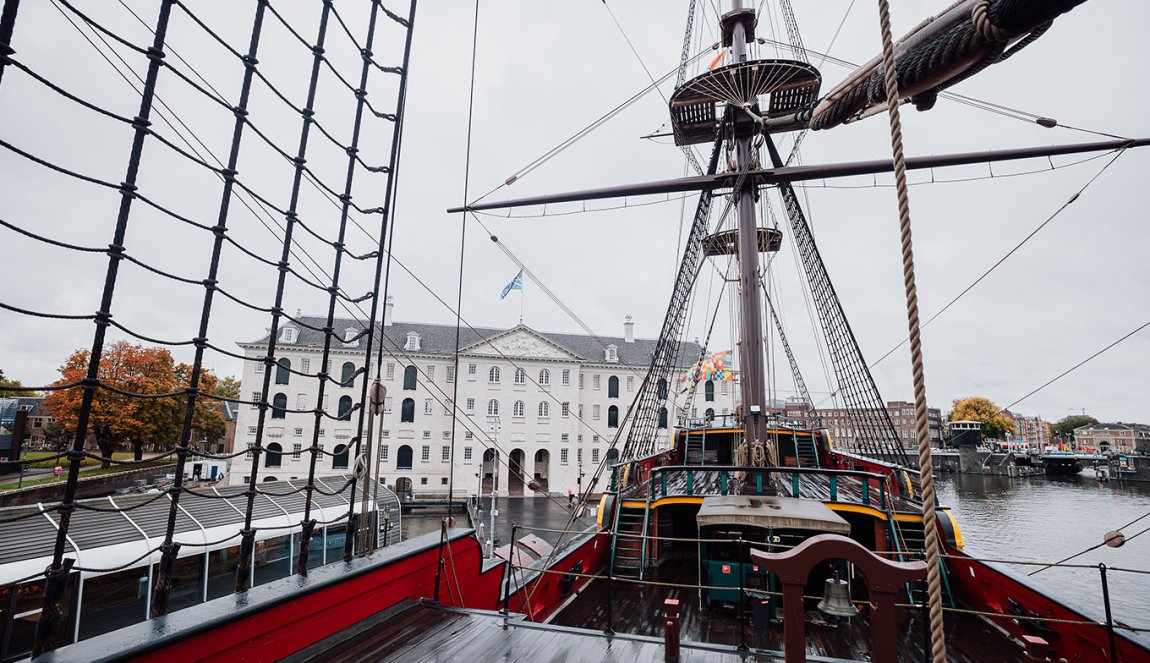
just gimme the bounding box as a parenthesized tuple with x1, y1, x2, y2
(447, 138, 1150, 214)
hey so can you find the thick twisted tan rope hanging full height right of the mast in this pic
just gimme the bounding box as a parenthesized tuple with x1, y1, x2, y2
(879, 0, 946, 663)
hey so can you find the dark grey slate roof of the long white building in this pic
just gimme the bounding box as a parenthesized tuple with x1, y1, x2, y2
(239, 316, 702, 368)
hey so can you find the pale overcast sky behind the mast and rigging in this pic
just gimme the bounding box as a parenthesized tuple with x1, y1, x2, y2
(0, 0, 1150, 422)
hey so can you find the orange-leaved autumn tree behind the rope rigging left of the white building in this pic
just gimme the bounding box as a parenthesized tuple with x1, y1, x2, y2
(44, 341, 223, 467)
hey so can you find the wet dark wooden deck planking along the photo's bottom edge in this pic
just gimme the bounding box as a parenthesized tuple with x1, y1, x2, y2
(312, 588, 1026, 663)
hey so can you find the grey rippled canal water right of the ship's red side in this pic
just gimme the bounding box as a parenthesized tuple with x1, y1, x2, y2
(935, 473, 1150, 642)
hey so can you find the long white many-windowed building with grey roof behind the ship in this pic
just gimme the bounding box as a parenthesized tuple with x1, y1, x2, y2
(230, 317, 738, 495)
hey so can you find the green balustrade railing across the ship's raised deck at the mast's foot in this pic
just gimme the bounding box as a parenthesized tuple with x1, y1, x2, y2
(647, 465, 896, 510)
